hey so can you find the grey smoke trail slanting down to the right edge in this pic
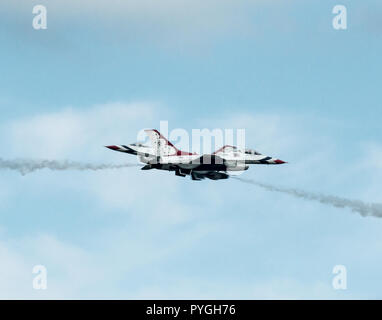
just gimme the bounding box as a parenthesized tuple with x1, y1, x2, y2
(233, 177, 382, 218)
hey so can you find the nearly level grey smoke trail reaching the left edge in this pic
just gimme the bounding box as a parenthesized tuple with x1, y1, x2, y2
(0, 158, 139, 175)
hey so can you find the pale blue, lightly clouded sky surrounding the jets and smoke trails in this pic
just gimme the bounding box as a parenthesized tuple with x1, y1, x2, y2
(0, 0, 382, 299)
